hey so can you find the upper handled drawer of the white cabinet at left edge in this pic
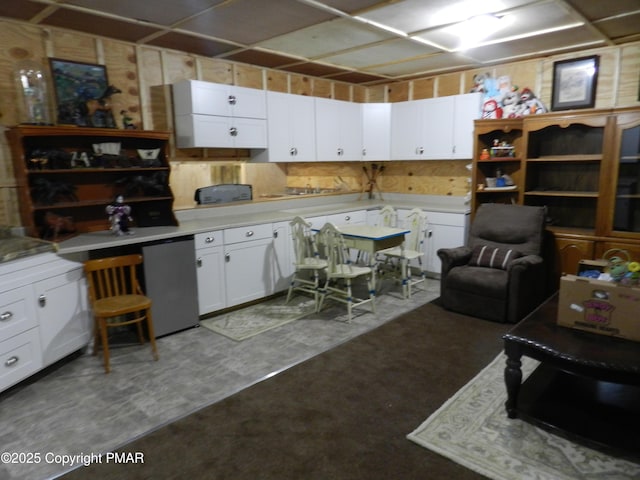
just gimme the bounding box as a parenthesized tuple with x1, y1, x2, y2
(0, 286, 37, 341)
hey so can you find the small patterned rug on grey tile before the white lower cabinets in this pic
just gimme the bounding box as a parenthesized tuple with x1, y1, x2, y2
(200, 297, 314, 342)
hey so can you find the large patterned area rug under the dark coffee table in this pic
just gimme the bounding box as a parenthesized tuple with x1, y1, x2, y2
(407, 354, 640, 480)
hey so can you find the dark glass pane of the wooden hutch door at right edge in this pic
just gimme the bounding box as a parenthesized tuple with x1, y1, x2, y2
(613, 125, 640, 232)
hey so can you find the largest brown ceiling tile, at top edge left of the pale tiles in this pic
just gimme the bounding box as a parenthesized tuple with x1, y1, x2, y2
(175, 0, 335, 45)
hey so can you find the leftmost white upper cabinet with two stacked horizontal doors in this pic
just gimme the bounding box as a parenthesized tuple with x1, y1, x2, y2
(173, 80, 267, 148)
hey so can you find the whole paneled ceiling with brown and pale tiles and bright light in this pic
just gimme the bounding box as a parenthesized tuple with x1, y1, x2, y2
(0, 0, 640, 85)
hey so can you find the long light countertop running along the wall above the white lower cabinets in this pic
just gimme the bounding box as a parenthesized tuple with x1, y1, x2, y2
(57, 194, 469, 255)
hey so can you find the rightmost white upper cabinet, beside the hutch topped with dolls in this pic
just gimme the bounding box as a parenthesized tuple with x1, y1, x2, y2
(391, 93, 481, 160)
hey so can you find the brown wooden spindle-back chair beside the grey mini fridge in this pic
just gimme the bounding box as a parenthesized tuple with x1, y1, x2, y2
(84, 254, 158, 373)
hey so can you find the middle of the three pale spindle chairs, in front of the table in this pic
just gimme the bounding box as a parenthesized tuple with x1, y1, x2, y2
(318, 223, 376, 321)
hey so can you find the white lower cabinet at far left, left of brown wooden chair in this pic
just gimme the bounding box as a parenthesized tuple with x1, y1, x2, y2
(0, 253, 91, 391)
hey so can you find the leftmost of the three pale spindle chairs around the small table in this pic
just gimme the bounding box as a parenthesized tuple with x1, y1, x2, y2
(286, 217, 327, 312)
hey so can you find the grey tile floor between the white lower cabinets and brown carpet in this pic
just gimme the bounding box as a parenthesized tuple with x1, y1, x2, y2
(0, 279, 439, 480)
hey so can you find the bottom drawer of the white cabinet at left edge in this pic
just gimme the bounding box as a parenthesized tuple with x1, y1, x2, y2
(0, 328, 42, 391)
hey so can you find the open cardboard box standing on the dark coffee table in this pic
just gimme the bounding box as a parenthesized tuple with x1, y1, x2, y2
(557, 275, 640, 341)
